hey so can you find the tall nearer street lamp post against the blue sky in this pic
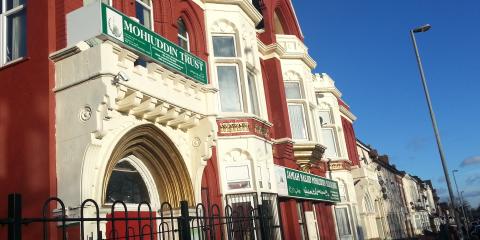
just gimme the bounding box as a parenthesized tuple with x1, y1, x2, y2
(410, 24, 461, 235)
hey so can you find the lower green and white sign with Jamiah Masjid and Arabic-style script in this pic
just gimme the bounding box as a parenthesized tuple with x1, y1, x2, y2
(275, 166, 340, 202)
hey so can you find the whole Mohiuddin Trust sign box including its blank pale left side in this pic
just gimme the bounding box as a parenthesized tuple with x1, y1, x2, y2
(67, 2, 208, 84)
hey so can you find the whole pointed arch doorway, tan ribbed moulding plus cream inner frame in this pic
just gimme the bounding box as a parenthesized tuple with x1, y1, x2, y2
(102, 124, 195, 208)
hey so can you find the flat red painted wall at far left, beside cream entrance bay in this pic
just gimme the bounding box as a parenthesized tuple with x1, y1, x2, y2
(0, 1, 56, 239)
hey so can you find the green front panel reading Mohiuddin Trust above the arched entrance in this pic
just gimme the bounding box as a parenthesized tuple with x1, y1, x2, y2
(101, 4, 208, 84)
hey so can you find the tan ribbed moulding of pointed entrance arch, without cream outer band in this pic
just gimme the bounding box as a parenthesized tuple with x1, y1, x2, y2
(102, 124, 195, 208)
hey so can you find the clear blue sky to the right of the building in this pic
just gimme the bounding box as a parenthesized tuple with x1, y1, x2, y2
(292, 0, 480, 207)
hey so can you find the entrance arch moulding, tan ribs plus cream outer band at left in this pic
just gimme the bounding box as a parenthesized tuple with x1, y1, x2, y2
(81, 124, 195, 207)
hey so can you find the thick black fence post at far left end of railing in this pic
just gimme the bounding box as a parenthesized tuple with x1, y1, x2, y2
(8, 193, 22, 240)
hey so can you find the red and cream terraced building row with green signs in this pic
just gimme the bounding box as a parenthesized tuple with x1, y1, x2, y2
(0, 0, 442, 240)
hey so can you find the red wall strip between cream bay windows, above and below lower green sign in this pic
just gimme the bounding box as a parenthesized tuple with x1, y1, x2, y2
(258, 0, 336, 239)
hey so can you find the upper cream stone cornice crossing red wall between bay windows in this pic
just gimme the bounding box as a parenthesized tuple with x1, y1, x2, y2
(257, 39, 317, 69)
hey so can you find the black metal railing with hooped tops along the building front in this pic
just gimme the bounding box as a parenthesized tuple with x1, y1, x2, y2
(0, 194, 281, 240)
